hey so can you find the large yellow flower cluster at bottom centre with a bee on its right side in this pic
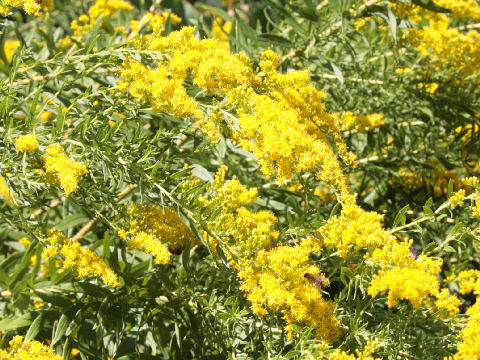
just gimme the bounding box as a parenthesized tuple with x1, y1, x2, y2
(238, 239, 340, 341)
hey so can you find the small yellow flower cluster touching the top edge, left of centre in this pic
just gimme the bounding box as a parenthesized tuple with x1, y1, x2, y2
(70, 0, 133, 36)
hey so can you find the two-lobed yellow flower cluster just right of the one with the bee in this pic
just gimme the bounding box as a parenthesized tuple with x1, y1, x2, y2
(317, 197, 448, 308)
